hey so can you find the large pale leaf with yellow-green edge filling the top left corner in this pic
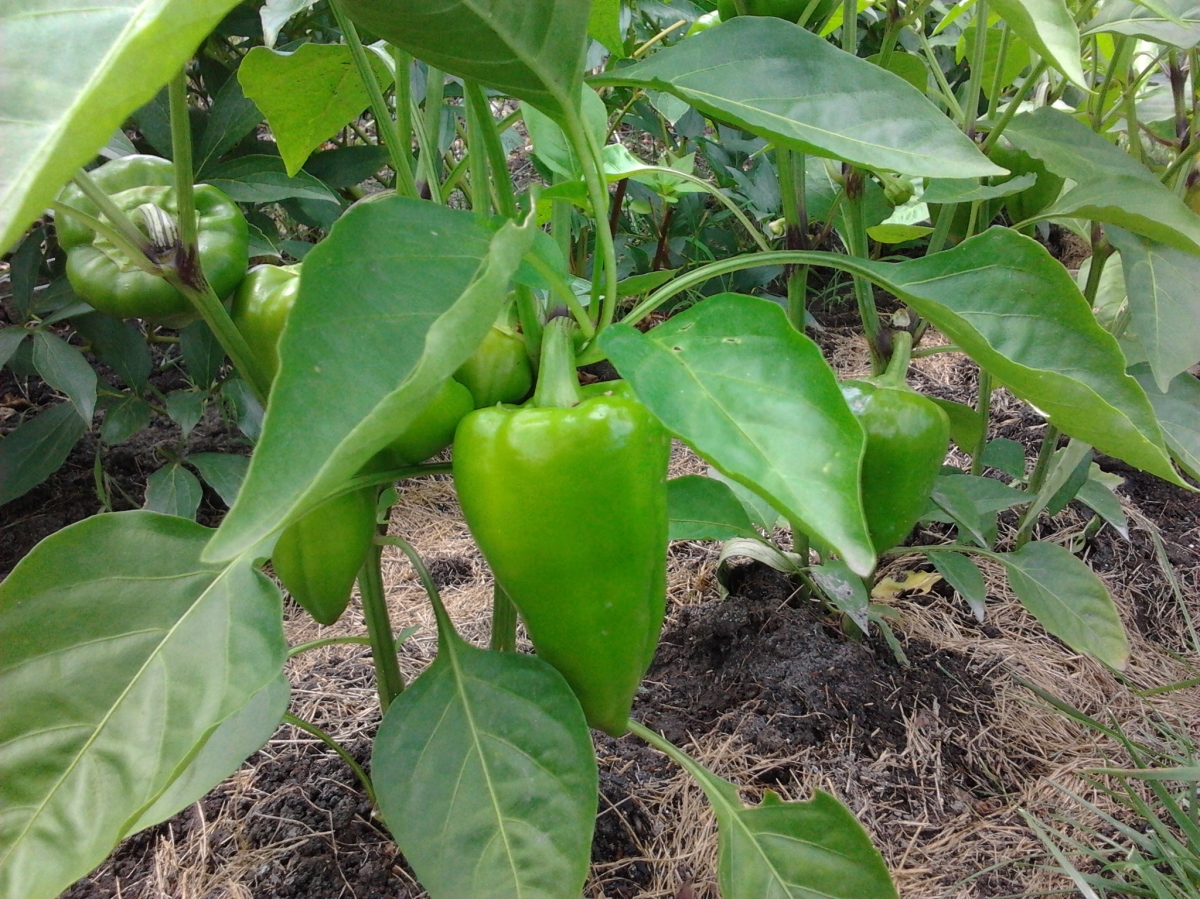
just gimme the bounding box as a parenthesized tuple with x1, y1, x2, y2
(0, 0, 235, 253)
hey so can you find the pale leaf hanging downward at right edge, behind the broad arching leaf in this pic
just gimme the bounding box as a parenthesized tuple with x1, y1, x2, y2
(1104, 228, 1200, 392)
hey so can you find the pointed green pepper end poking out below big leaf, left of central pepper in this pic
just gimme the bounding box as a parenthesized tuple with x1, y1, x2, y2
(271, 487, 376, 624)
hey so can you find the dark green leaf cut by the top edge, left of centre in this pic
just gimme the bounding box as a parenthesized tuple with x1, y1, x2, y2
(344, 0, 590, 121)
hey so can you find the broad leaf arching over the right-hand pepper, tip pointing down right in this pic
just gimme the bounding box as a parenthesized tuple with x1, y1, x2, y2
(858, 228, 1182, 484)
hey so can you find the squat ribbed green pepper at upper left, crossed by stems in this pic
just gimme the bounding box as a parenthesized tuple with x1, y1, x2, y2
(56, 156, 250, 325)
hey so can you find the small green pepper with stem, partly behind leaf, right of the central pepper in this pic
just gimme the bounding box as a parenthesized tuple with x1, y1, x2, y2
(841, 331, 950, 552)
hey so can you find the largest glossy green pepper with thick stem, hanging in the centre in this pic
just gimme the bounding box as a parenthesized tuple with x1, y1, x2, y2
(454, 319, 671, 736)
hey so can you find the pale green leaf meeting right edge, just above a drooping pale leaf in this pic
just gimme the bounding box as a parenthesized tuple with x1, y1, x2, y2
(1004, 107, 1200, 253)
